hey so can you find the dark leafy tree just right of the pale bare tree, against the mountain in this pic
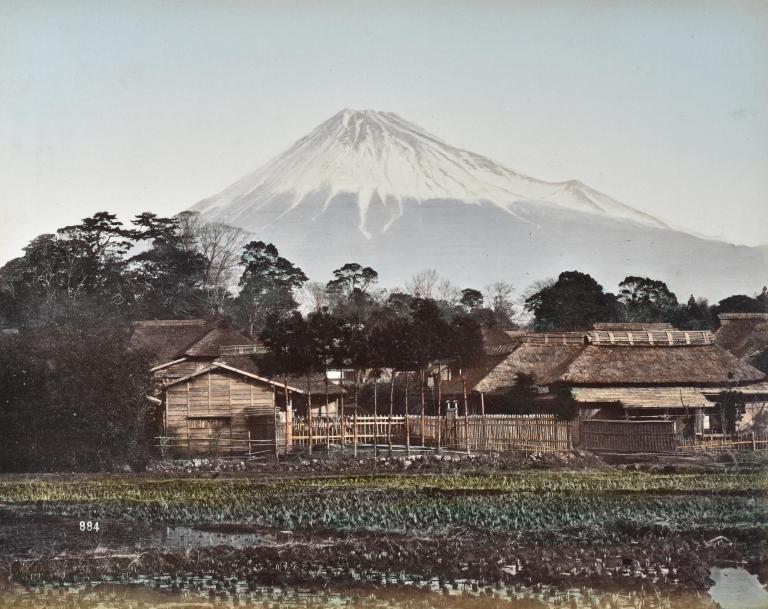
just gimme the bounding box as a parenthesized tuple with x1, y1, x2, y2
(235, 241, 307, 336)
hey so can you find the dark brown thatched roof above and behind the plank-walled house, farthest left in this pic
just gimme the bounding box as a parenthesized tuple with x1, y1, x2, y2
(131, 319, 214, 365)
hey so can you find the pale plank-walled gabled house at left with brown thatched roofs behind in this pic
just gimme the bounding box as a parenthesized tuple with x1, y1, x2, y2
(132, 320, 343, 453)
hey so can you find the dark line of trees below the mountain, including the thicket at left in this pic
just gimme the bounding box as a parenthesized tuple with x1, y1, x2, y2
(0, 212, 768, 469)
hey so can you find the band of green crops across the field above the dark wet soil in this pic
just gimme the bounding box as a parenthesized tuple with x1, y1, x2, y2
(0, 471, 768, 539)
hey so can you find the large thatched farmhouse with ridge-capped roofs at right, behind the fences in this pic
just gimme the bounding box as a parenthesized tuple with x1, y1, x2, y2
(446, 324, 768, 435)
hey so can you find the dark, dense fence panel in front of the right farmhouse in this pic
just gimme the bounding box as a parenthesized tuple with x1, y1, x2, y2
(579, 419, 677, 453)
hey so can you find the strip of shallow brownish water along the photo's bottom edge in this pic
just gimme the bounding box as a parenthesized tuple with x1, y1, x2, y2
(0, 578, 724, 609)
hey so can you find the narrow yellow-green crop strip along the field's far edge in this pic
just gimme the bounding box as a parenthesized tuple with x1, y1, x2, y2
(0, 471, 768, 503)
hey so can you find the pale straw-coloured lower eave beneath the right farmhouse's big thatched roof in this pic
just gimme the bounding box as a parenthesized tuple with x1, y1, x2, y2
(571, 386, 715, 408)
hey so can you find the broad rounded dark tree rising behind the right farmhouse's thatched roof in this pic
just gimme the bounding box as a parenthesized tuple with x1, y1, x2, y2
(525, 271, 617, 331)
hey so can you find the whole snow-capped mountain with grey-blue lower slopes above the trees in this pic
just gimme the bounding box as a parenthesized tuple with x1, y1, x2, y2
(191, 110, 768, 298)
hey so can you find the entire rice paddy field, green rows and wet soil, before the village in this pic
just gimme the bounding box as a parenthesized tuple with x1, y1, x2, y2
(0, 469, 768, 606)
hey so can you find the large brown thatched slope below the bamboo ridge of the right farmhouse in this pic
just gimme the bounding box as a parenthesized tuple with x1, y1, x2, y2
(560, 345, 765, 386)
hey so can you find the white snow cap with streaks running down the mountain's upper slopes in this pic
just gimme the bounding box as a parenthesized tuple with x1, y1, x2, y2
(193, 110, 665, 236)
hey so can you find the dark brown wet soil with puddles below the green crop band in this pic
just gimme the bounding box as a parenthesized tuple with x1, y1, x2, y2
(0, 512, 768, 590)
